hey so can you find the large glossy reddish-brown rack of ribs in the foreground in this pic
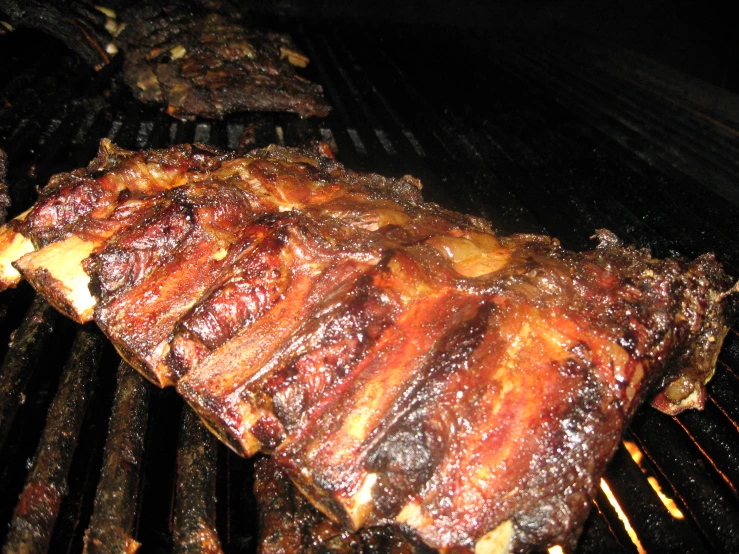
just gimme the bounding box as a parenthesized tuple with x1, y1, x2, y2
(0, 141, 737, 553)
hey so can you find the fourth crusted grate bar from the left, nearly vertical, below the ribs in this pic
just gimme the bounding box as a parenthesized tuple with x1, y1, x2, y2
(174, 409, 222, 554)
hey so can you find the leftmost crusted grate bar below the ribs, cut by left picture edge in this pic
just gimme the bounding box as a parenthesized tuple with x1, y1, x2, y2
(0, 295, 59, 448)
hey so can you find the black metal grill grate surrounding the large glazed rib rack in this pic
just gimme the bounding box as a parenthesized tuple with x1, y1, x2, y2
(0, 15, 739, 553)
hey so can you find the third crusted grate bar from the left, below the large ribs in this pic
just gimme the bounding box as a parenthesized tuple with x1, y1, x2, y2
(85, 362, 150, 553)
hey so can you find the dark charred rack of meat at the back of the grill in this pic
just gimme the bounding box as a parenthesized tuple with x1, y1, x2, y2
(116, 2, 330, 119)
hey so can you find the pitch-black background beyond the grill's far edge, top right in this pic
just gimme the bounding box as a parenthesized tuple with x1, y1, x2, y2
(249, 0, 739, 92)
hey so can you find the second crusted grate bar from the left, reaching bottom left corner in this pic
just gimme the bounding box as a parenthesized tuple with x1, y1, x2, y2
(4, 326, 105, 552)
